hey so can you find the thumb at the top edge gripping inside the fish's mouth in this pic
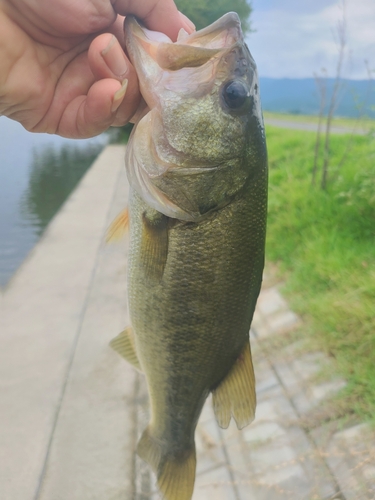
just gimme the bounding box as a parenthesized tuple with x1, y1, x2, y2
(112, 0, 195, 41)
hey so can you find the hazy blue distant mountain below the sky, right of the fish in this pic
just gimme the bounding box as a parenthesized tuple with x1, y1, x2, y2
(260, 77, 375, 118)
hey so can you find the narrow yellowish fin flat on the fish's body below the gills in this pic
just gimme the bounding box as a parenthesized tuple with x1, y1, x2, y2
(141, 210, 168, 281)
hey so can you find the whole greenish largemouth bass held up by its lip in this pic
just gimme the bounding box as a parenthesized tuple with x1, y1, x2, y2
(111, 12, 267, 500)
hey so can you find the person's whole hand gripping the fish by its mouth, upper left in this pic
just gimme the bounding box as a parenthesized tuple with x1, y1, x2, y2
(0, 0, 194, 138)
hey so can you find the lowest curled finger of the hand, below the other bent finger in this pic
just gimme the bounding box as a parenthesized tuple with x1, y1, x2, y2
(57, 78, 126, 139)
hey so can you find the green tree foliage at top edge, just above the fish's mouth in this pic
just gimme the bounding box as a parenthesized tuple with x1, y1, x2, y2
(175, 0, 252, 33)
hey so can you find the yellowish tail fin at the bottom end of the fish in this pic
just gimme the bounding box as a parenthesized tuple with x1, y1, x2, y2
(137, 428, 196, 500)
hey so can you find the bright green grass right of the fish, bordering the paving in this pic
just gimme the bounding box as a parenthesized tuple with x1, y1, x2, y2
(267, 126, 375, 421)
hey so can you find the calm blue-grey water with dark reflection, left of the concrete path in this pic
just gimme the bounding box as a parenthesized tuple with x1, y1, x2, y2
(0, 117, 109, 287)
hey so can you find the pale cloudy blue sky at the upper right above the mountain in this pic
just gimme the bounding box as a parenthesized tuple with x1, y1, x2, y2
(246, 0, 375, 79)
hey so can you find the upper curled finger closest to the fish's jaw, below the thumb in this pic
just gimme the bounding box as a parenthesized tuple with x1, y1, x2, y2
(88, 33, 141, 126)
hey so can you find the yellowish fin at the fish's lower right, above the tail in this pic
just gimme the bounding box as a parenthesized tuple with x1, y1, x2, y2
(212, 342, 256, 429)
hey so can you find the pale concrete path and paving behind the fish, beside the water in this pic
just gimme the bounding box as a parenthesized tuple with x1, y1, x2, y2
(0, 146, 375, 500)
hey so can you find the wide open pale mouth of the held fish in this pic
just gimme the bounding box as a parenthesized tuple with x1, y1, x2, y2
(124, 12, 244, 108)
